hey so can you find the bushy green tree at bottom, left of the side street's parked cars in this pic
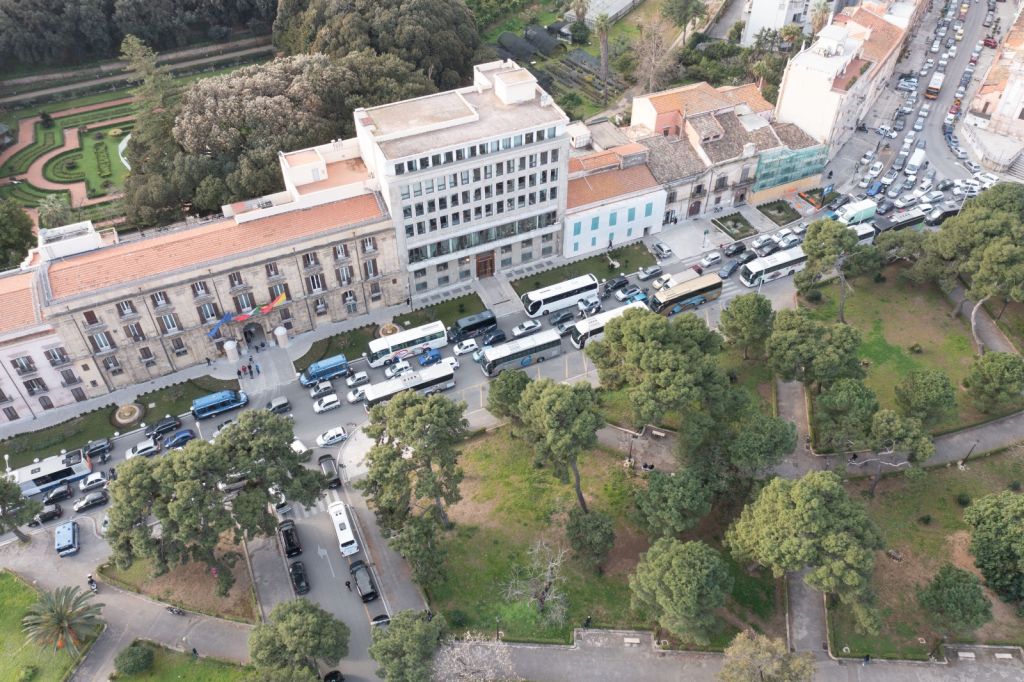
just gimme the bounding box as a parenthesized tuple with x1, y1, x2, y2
(249, 598, 349, 671)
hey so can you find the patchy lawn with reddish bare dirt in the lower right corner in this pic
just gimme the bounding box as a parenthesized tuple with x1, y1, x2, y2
(829, 449, 1024, 658)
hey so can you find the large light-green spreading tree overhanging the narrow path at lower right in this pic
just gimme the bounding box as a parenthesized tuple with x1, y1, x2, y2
(726, 471, 882, 631)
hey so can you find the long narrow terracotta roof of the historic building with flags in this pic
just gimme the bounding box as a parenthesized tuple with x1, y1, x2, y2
(47, 194, 383, 299)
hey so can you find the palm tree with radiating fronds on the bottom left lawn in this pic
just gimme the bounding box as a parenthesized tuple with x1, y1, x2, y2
(22, 586, 103, 655)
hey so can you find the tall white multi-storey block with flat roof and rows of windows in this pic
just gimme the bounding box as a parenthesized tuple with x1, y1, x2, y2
(354, 61, 568, 295)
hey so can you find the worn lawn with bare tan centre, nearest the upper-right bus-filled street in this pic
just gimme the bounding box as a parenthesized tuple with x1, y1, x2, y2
(801, 266, 1020, 431)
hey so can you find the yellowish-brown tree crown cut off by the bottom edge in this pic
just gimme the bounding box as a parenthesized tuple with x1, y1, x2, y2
(718, 630, 814, 682)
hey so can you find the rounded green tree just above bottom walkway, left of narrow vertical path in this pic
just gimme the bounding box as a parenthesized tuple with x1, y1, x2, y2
(630, 538, 732, 644)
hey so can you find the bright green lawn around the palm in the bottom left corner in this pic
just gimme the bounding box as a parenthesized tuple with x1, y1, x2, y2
(0, 570, 91, 682)
